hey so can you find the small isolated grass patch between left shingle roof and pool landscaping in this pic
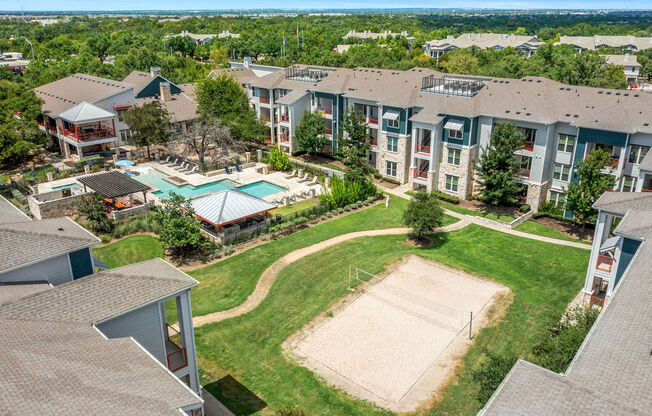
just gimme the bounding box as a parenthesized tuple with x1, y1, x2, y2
(93, 235, 165, 268)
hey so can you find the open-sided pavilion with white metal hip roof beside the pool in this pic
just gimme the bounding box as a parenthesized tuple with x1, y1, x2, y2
(190, 189, 278, 242)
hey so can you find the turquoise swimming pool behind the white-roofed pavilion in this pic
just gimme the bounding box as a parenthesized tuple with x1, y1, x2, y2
(134, 169, 285, 199)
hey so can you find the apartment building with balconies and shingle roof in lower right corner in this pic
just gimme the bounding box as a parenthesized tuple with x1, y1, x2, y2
(478, 192, 652, 416)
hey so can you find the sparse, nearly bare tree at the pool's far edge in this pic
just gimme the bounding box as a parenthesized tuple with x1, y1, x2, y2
(171, 120, 244, 170)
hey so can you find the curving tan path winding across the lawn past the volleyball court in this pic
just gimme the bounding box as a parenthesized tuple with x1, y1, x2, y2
(193, 219, 470, 326)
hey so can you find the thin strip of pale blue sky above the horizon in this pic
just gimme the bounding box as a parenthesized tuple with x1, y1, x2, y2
(8, 0, 652, 10)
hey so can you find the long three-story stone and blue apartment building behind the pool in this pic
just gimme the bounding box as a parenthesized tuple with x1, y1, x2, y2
(225, 65, 652, 209)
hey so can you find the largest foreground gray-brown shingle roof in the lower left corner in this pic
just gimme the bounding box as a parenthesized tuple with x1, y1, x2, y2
(0, 259, 201, 416)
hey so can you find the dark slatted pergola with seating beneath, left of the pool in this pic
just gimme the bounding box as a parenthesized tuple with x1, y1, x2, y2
(77, 170, 151, 219)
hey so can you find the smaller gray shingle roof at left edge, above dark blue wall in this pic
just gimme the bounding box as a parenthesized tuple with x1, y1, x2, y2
(0, 217, 100, 272)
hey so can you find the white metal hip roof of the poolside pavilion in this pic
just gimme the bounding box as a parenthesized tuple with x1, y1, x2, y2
(190, 189, 277, 225)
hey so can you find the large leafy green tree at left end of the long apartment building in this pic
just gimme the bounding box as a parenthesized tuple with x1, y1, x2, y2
(195, 74, 269, 142)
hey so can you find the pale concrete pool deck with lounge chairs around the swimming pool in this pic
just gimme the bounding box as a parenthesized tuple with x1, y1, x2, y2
(38, 162, 322, 205)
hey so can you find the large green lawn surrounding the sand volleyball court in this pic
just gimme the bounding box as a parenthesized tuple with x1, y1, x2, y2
(193, 224, 588, 416)
